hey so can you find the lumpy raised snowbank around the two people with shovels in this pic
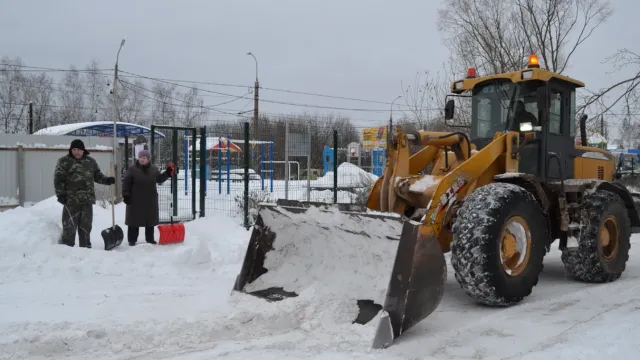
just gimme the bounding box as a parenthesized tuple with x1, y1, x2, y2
(0, 197, 248, 274)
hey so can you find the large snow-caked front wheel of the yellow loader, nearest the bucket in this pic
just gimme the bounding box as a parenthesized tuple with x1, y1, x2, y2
(451, 183, 550, 306)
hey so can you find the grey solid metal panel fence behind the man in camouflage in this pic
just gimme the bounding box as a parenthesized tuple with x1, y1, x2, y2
(0, 134, 113, 208)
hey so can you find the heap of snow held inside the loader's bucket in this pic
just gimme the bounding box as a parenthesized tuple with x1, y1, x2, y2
(240, 208, 402, 325)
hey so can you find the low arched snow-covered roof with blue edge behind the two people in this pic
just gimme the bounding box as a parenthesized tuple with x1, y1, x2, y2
(33, 121, 166, 139)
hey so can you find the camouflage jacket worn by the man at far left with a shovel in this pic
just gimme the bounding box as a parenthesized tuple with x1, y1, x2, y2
(53, 154, 112, 206)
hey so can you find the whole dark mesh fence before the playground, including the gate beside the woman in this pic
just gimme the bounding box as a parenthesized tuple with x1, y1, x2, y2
(145, 121, 387, 226)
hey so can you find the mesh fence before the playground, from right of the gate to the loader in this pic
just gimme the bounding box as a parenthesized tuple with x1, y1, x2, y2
(196, 120, 376, 224)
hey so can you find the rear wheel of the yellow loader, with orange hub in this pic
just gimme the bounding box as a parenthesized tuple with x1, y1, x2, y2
(562, 190, 631, 283)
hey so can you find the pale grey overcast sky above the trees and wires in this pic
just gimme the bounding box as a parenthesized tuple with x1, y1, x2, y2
(0, 0, 640, 132)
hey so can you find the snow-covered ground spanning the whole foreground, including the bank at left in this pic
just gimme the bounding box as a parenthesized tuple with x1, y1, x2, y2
(0, 198, 640, 360)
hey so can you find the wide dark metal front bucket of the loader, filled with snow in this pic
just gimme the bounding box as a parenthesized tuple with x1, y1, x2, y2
(234, 201, 446, 347)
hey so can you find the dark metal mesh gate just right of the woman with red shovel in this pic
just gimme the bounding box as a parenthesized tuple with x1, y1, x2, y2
(150, 125, 204, 223)
